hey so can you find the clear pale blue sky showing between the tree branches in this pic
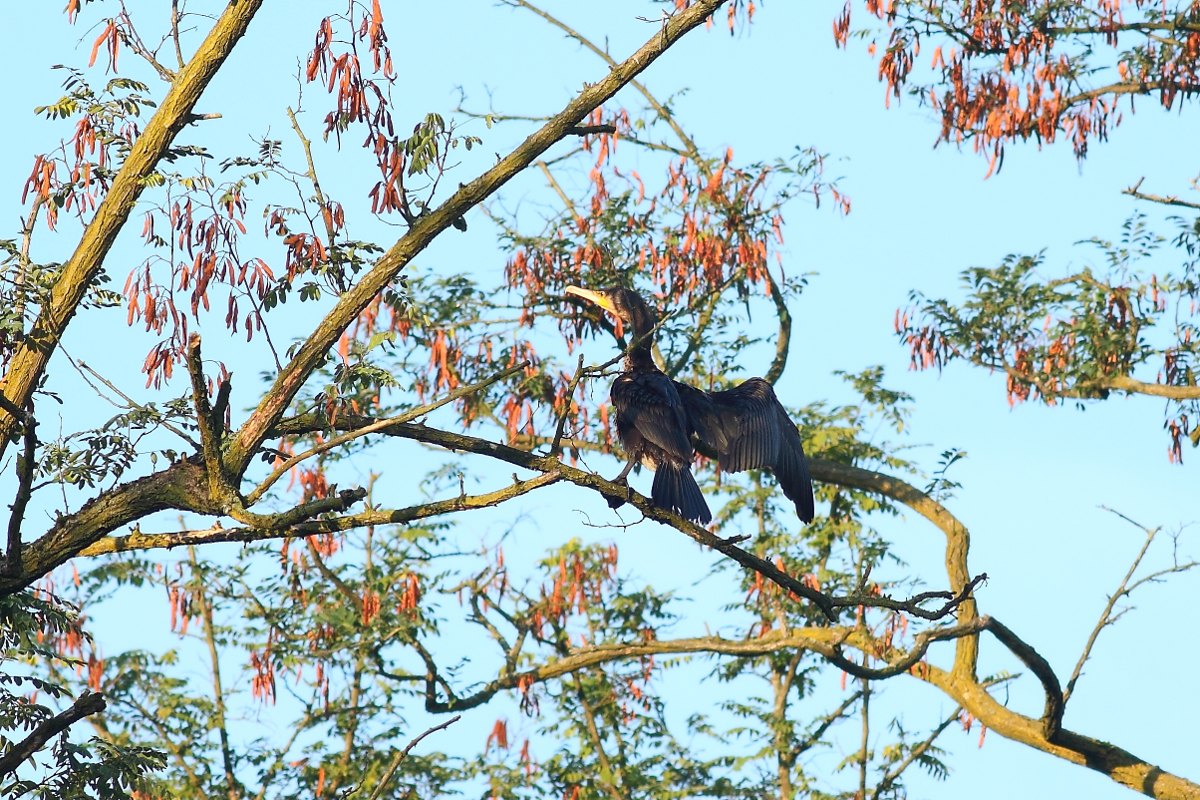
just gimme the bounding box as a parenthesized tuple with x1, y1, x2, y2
(0, 0, 1200, 800)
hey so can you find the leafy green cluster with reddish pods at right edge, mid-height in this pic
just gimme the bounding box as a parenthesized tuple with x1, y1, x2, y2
(896, 215, 1200, 461)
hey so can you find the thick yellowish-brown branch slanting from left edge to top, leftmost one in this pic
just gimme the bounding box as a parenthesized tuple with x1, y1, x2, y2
(0, 0, 263, 455)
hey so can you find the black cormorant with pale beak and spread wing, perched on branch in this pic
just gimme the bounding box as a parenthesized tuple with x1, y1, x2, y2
(566, 287, 814, 524)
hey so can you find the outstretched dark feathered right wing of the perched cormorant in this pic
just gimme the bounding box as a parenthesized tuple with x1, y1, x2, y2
(676, 378, 815, 523)
